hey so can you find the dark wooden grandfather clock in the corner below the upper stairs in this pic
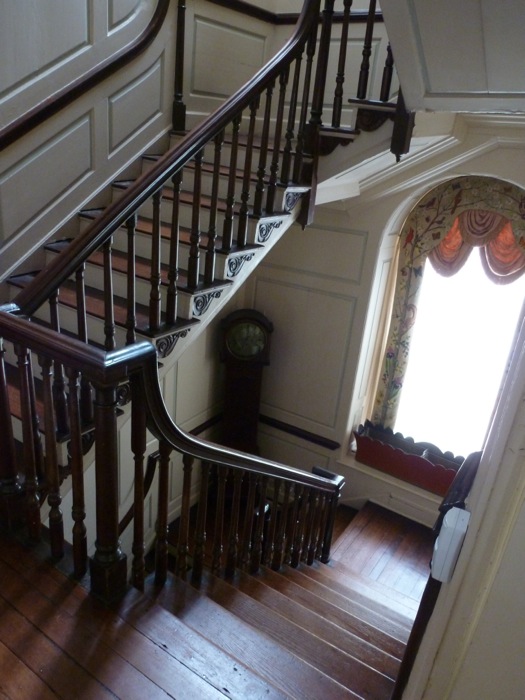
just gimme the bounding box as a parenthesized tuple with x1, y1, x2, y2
(221, 309, 273, 454)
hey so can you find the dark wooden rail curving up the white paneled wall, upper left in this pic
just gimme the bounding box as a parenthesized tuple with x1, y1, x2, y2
(0, 0, 170, 151)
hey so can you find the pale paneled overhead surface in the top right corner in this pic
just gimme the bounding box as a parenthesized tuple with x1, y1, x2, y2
(381, 0, 525, 112)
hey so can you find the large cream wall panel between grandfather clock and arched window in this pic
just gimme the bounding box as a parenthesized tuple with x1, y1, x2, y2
(254, 277, 356, 439)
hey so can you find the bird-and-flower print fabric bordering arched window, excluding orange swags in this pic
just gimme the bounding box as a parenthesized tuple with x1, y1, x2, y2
(371, 175, 525, 427)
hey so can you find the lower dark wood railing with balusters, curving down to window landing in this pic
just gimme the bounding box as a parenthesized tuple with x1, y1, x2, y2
(0, 311, 343, 601)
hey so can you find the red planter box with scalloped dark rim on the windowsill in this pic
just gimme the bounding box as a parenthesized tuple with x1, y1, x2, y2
(354, 421, 463, 496)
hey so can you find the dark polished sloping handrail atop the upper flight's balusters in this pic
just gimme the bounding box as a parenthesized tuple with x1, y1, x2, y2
(14, 0, 320, 316)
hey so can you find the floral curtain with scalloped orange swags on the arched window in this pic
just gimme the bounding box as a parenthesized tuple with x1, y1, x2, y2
(371, 176, 525, 427)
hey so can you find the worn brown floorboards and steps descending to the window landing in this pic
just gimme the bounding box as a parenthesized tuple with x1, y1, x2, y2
(0, 504, 432, 700)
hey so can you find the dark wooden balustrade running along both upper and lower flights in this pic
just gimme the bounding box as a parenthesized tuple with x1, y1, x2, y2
(0, 0, 410, 599)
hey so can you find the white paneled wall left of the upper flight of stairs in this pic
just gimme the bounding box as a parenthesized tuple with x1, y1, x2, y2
(0, 0, 176, 281)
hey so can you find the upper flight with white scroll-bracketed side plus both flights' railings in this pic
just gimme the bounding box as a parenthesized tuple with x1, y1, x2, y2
(0, 0, 414, 600)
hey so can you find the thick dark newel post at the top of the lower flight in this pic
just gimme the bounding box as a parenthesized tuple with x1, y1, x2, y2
(90, 386, 127, 602)
